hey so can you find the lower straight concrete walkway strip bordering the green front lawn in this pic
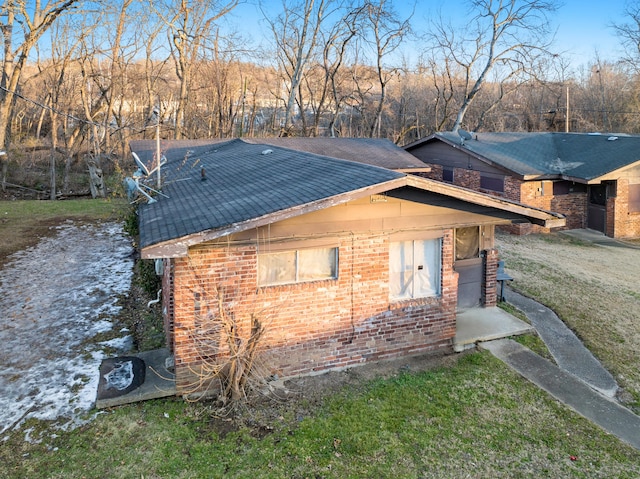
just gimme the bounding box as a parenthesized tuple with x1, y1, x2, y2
(480, 339, 640, 449)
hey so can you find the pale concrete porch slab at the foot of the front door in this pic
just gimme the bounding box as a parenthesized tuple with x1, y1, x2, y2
(453, 306, 535, 352)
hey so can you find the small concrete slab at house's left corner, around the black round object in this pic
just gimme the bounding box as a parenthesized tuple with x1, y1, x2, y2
(96, 349, 176, 409)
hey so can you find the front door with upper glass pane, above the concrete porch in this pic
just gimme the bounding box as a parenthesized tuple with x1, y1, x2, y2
(453, 226, 484, 310)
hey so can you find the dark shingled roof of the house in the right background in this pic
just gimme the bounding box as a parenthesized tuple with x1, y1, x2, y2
(412, 132, 640, 181)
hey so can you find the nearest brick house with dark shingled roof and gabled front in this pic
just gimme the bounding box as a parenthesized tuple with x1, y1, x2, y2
(131, 140, 564, 393)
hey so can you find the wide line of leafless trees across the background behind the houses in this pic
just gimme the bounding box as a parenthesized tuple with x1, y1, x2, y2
(0, 0, 640, 196)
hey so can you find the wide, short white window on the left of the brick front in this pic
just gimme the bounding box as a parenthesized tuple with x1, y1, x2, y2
(258, 248, 338, 286)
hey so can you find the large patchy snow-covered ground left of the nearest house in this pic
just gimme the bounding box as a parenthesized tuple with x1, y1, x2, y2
(0, 222, 133, 437)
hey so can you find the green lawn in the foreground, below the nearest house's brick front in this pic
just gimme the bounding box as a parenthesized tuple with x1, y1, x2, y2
(5, 353, 640, 479)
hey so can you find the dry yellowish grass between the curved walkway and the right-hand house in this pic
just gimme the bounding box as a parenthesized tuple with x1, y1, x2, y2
(497, 234, 640, 408)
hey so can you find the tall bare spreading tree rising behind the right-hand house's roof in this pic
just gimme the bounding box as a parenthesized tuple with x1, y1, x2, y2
(431, 0, 556, 131)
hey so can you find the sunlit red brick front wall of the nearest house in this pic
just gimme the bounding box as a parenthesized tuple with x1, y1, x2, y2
(168, 230, 458, 391)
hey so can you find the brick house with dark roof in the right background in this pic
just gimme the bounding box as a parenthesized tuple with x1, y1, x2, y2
(405, 132, 640, 238)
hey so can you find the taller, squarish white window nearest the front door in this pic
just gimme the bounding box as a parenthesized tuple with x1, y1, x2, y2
(389, 238, 442, 300)
